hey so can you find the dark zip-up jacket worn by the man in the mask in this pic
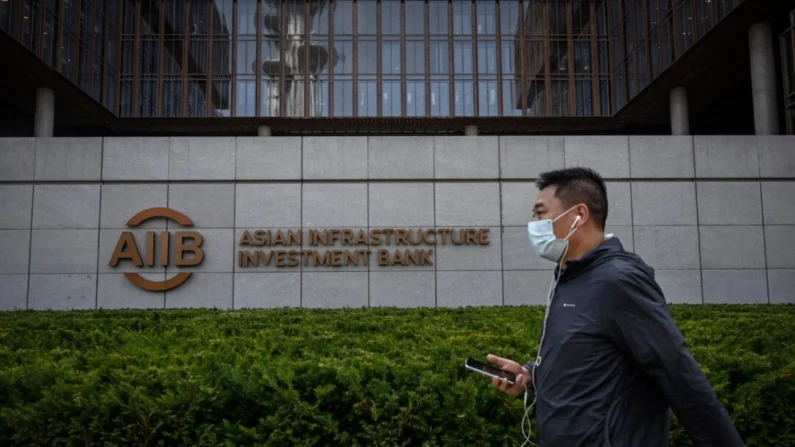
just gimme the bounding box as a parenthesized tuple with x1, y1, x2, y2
(525, 238, 744, 447)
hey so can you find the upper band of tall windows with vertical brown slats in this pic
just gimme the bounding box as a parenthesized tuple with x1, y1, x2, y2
(0, 0, 748, 117)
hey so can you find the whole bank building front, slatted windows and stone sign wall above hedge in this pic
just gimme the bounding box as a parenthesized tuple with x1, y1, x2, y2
(0, 0, 795, 310)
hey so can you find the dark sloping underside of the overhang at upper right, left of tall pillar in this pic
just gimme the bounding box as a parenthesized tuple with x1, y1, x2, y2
(614, 0, 795, 123)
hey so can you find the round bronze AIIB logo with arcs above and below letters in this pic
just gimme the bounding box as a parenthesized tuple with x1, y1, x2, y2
(108, 208, 204, 292)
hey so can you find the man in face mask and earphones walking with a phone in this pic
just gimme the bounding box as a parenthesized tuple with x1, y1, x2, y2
(488, 168, 744, 447)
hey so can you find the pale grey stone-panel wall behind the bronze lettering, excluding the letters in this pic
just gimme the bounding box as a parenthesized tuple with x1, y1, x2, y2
(0, 136, 795, 309)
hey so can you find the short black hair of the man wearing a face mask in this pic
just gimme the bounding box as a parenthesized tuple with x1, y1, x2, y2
(536, 168, 607, 230)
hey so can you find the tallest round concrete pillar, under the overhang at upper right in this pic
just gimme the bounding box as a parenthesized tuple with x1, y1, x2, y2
(748, 22, 778, 135)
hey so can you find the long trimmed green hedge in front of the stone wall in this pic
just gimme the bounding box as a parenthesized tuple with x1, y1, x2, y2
(0, 306, 795, 446)
